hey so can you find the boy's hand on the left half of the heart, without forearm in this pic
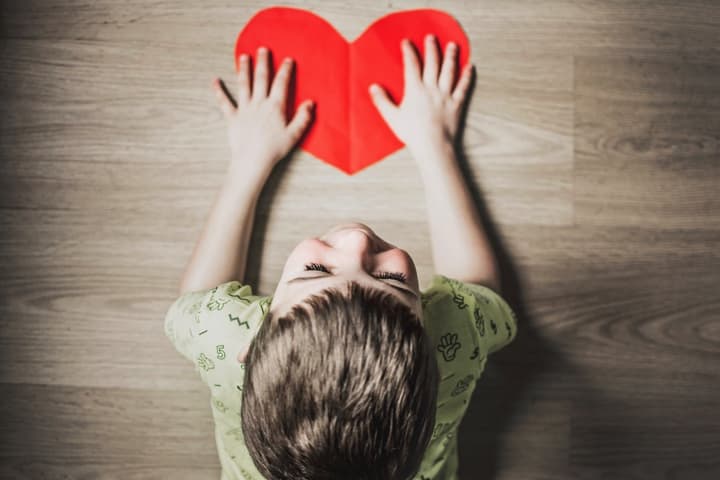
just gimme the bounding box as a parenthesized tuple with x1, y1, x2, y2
(212, 47, 314, 178)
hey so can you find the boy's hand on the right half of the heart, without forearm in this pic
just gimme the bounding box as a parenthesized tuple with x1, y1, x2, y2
(369, 34, 472, 161)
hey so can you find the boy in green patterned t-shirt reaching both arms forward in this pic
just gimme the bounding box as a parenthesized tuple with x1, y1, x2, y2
(165, 36, 517, 480)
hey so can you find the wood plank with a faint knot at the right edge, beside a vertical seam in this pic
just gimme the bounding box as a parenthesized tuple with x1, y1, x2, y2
(575, 53, 720, 229)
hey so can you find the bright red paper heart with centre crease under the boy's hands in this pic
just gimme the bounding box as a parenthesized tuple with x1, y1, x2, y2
(235, 7, 470, 175)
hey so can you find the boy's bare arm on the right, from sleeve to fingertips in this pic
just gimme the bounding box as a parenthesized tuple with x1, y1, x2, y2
(370, 36, 500, 293)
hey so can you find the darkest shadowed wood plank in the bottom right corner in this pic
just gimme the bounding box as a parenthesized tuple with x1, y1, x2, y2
(569, 382, 720, 479)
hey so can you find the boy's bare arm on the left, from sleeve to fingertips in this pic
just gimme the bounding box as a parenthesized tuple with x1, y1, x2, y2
(180, 47, 312, 295)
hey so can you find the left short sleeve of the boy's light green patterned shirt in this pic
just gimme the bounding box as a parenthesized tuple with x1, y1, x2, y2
(165, 280, 271, 371)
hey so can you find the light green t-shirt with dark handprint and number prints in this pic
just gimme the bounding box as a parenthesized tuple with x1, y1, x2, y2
(165, 274, 517, 480)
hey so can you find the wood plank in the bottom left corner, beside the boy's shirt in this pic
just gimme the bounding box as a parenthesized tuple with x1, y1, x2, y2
(0, 384, 220, 479)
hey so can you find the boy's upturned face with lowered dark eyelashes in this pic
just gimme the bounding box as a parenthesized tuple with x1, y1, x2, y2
(238, 223, 423, 362)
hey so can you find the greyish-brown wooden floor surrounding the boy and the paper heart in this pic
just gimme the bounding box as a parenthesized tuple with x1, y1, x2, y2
(0, 0, 720, 480)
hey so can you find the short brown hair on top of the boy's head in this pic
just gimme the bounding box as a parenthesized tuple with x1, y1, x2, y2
(241, 282, 439, 480)
